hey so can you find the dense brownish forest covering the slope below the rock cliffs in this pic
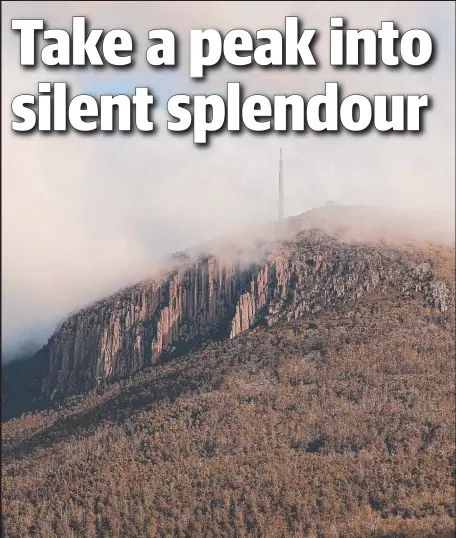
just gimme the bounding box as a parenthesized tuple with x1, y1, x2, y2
(2, 286, 455, 538)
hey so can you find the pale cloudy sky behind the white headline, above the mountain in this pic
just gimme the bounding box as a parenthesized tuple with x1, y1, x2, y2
(2, 1, 455, 351)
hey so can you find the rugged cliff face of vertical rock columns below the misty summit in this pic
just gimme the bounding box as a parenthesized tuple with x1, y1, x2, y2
(30, 227, 450, 400)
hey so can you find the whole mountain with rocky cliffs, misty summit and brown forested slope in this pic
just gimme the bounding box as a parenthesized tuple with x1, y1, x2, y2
(2, 205, 456, 538)
